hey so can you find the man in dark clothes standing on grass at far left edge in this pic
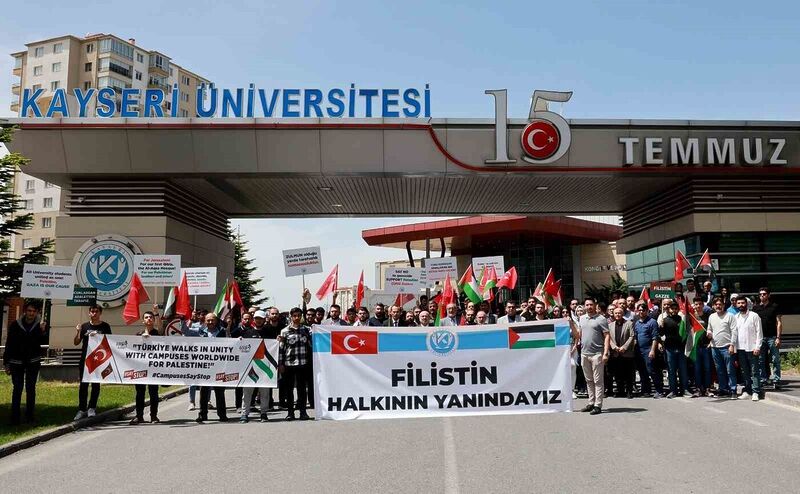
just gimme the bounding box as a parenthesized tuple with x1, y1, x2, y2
(3, 302, 48, 425)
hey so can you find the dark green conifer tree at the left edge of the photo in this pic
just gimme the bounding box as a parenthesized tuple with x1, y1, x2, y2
(0, 127, 53, 298)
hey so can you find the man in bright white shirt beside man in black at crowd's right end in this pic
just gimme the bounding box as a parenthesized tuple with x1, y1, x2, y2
(734, 295, 764, 401)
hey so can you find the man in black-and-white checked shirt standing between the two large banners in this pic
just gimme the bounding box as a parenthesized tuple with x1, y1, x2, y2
(278, 307, 311, 421)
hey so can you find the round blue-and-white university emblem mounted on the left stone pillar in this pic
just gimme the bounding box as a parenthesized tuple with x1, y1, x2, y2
(72, 235, 142, 307)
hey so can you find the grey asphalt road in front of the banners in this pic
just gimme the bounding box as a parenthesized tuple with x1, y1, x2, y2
(0, 395, 800, 494)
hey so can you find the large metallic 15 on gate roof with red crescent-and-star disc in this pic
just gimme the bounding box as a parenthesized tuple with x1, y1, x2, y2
(486, 89, 572, 165)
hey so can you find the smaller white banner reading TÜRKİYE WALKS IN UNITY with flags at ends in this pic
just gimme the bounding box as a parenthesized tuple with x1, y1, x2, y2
(83, 334, 278, 388)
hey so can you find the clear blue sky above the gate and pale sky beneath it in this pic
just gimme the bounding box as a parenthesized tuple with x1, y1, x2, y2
(0, 0, 800, 307)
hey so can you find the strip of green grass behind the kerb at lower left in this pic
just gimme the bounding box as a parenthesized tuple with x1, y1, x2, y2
(0, 370, 179, 445)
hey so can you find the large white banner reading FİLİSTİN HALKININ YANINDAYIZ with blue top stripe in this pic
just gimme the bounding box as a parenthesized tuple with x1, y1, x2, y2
(313, 319, 572, 420)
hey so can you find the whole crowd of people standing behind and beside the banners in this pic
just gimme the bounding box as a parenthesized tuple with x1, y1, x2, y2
(3, 280, 782, 425)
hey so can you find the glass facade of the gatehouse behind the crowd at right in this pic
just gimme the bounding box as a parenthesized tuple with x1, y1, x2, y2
(626, 232, 800, 314)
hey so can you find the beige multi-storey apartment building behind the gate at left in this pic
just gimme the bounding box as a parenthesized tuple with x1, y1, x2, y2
(11, 33, 209, 261)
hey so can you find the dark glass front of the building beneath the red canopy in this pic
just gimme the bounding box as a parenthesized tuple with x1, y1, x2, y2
(470, 234, 573, 304)
